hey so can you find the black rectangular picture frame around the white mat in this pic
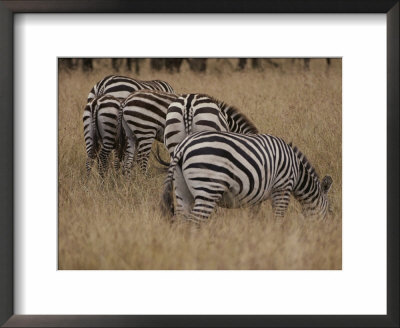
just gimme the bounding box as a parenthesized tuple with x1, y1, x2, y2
(0, 0, 400, 327)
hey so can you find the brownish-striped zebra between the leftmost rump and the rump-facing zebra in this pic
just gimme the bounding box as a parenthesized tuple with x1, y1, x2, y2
(121, 90, 178, 173)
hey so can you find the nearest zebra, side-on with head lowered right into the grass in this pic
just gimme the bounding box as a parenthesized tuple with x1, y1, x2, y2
(161, 131, 332, 223)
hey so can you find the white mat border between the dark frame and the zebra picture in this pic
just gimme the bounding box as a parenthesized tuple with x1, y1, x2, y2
(15, 14, 386, 314)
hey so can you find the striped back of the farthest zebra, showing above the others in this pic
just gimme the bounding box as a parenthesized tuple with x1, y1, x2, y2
(87, 75, 174, 103)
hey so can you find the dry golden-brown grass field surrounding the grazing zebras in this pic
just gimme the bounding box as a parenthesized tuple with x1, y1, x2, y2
(58, 59, 342, 270)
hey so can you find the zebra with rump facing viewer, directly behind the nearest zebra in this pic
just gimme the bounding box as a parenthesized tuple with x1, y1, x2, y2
(164, 94, 258, 156)
